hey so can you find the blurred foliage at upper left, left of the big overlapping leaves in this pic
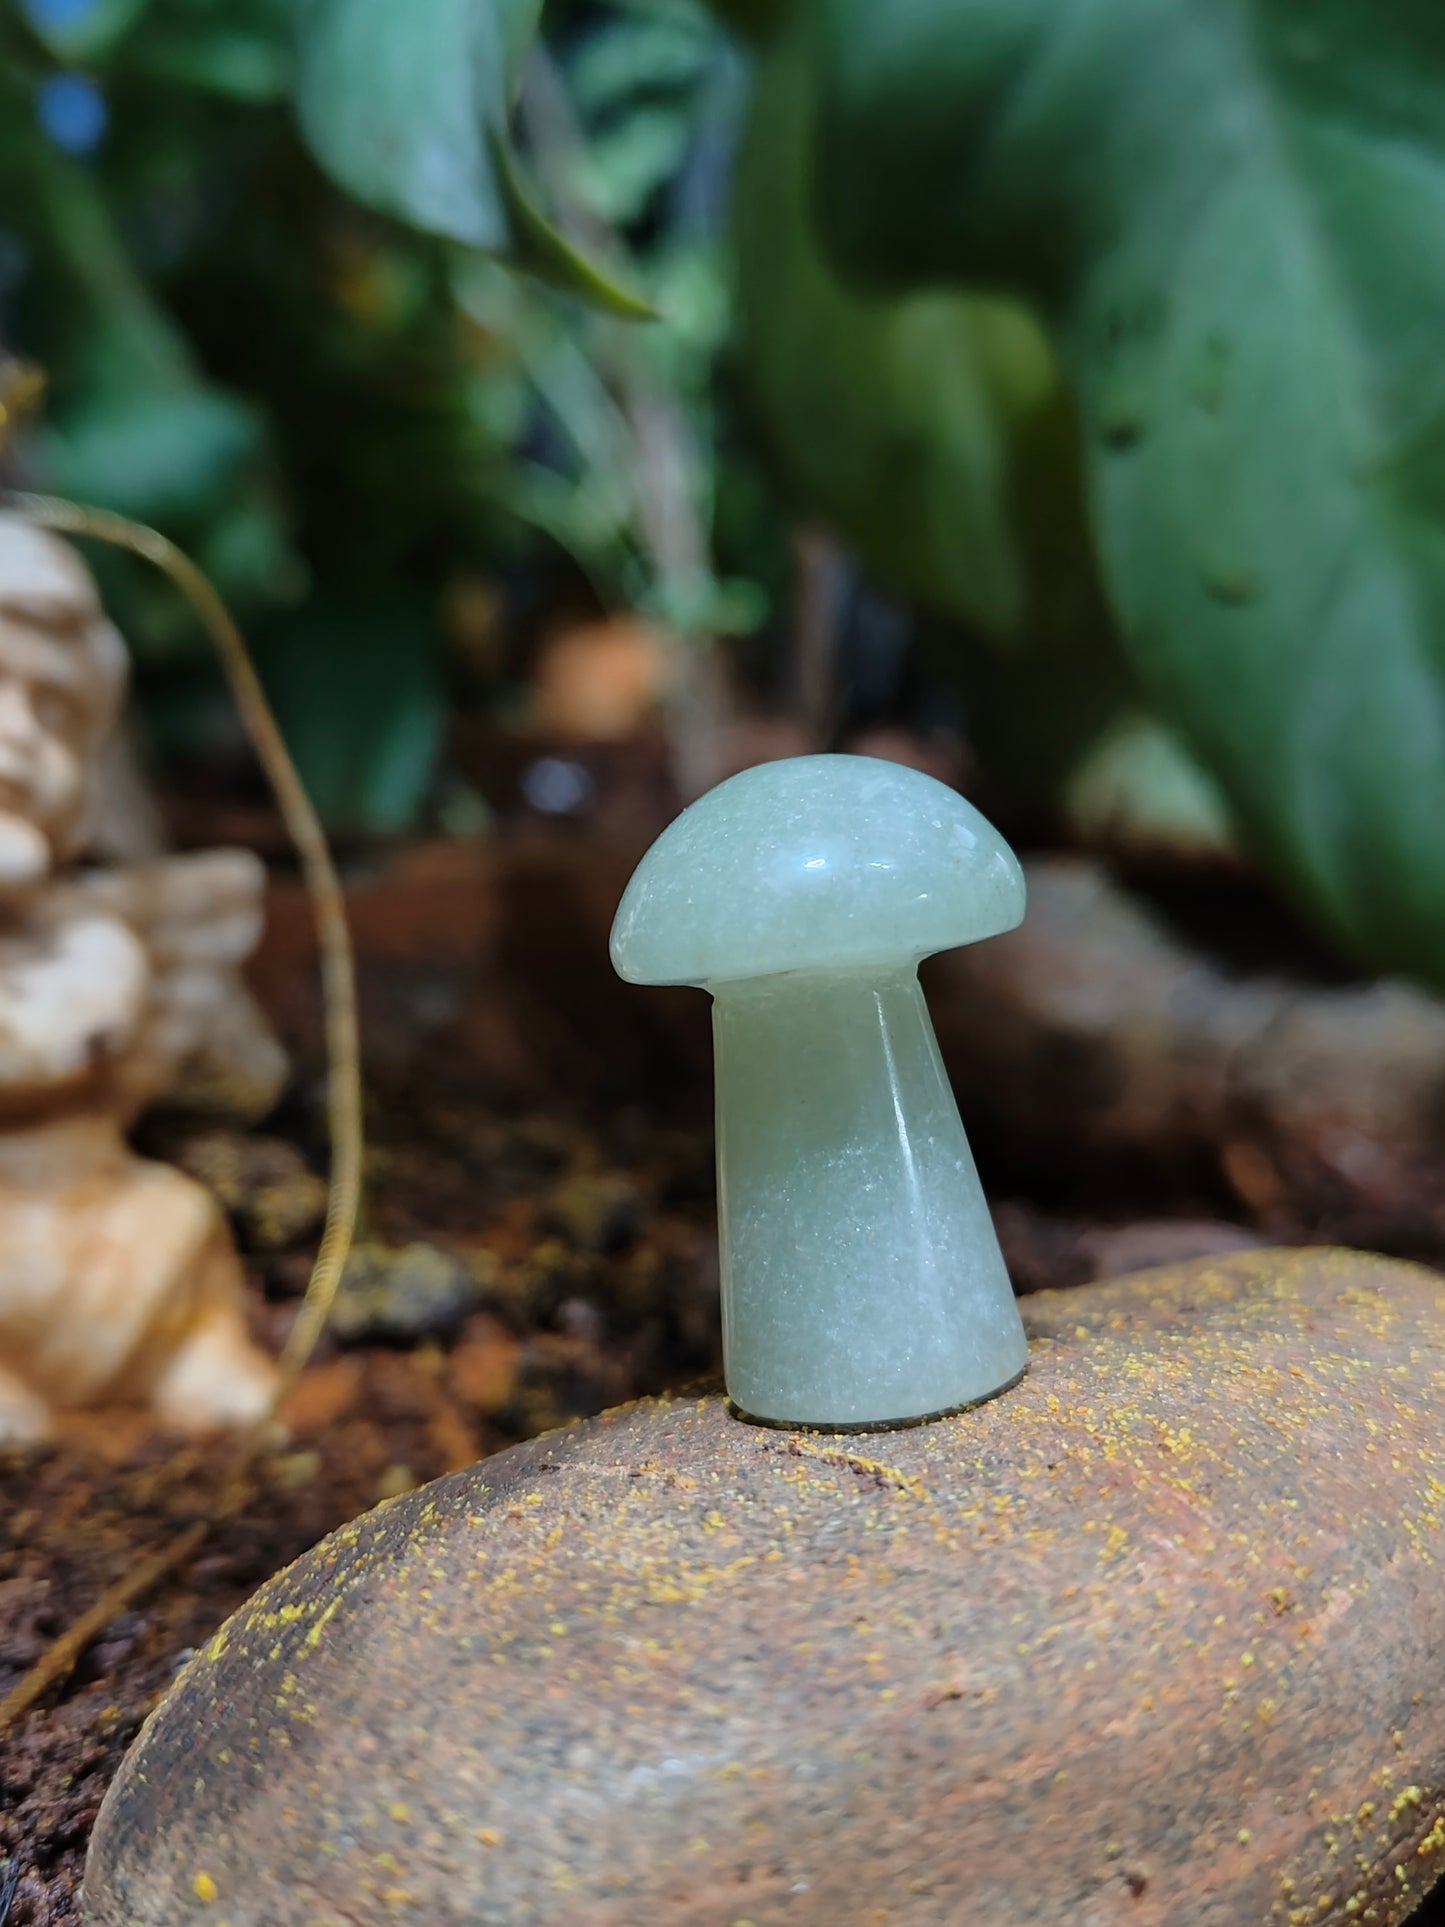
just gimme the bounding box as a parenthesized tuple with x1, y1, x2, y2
(0, 0, 776, 829)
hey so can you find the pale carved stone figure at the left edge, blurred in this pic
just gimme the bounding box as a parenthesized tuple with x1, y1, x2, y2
(0, 515, 283, 1439)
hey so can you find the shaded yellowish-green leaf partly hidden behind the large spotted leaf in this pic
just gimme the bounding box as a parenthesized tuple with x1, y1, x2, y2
(732, 32, 1060, 638)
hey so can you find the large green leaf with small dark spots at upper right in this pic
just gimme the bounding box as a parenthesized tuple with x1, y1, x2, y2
(813, 0, 1445, 985)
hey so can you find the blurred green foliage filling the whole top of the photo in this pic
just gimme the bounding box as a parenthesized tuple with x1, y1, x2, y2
(0, 0, 1445, 985)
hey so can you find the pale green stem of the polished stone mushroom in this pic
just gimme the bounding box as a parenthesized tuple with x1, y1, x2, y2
(709, 964, 1027, 1428)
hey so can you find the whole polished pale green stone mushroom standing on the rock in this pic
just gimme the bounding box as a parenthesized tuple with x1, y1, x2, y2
(613, 755, 1027, 1430)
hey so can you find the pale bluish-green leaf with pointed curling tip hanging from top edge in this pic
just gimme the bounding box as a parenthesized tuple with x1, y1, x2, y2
(297, 0, 651, 314)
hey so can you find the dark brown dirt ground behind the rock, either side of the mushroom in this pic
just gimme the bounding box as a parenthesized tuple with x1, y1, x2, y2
(0, 832, 1445, 1927)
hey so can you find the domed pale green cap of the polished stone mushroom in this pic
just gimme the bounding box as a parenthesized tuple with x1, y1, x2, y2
(613, 755, 1023, 985)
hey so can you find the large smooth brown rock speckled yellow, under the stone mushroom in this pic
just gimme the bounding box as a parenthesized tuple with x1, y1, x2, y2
(87, 1253, 1445, 1927)
